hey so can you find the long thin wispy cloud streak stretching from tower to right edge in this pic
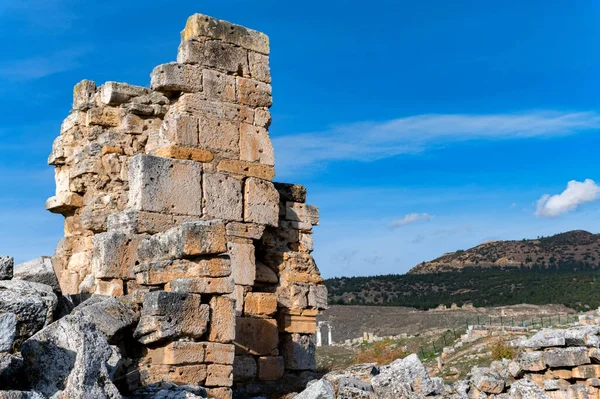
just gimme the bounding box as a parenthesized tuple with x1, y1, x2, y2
(273, 111, 600, 174)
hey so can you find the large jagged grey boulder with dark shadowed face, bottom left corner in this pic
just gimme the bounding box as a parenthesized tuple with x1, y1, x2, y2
(21, 314, 121, 399)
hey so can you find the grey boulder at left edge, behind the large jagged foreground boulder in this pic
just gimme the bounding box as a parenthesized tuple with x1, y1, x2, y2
(0, 280, 58, 345)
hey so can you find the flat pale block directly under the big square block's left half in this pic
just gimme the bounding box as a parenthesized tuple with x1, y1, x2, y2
(107, 210, 175, 235)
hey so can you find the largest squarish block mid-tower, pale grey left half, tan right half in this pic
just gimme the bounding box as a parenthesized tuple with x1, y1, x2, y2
(128, 154, 202, 216)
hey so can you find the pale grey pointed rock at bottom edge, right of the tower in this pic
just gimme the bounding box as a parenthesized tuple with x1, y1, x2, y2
(371, 354, 437, 399)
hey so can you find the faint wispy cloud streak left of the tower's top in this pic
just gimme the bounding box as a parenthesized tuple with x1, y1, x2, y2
(0, 48, 90, 81)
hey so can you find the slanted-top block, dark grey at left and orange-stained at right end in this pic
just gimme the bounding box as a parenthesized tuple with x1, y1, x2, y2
(138, 220, 227, 261)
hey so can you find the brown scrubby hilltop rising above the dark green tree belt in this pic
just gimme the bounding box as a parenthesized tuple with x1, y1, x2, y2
(408, 230, 600, 274)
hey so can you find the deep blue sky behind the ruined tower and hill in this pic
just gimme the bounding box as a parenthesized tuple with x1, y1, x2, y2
(0, 0, 600, 277)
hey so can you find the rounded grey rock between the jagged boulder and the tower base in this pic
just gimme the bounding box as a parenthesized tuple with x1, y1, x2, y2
(72, 295, 138, 344)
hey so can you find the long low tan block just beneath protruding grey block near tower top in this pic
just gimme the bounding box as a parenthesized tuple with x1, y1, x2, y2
(176, 93, 254, 124)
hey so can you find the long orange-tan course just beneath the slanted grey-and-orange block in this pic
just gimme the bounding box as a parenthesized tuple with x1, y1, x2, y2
(133, 256, 231, 285)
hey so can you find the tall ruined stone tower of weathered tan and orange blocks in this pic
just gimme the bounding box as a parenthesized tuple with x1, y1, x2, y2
(46, 14, 327, 398)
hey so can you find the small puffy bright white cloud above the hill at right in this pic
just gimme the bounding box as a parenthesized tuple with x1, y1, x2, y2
(535, 179, 600, 217)
